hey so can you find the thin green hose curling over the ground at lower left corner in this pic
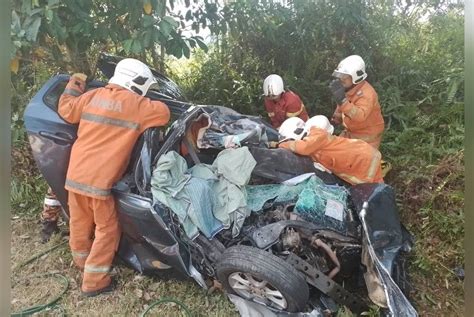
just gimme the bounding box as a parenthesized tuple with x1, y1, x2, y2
(11, 241, 69, 317)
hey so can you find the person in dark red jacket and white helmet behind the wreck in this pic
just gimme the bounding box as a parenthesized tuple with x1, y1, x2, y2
(263, 74, 308, 129)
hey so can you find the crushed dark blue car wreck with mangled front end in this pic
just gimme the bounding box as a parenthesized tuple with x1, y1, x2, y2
(24, 55, 416, 316)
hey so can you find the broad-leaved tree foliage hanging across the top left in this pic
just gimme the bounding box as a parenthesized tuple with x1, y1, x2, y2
(11, 0, 219, 75)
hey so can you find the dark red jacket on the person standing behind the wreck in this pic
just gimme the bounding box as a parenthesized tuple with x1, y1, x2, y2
(265, 91, 308, 129)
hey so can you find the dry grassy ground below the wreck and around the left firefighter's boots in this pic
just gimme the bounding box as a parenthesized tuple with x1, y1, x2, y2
(11, 216, 239, 316)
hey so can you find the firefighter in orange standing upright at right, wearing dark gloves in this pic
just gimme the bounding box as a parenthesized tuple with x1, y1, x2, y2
(329, 55, 384, 149)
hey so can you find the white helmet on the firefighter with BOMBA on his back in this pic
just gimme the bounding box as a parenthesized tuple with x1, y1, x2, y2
(109, 58, 156, 96)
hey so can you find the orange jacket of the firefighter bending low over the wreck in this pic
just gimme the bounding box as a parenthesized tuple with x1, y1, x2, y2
(279, 127, 383, 185)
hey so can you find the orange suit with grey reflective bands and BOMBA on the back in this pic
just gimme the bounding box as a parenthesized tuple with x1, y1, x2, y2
(58, 77, 170, 292)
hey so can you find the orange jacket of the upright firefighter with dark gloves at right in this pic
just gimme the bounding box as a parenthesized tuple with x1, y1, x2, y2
(333, 80, 384, 149)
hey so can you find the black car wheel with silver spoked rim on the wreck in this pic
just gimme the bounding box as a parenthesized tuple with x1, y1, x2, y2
(217, 245, 309, 312)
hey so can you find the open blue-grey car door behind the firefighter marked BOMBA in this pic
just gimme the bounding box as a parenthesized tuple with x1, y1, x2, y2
(24, 75, 103, 212)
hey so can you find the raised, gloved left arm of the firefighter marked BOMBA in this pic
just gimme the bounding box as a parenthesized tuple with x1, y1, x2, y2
(58, 73, 87, 123)
